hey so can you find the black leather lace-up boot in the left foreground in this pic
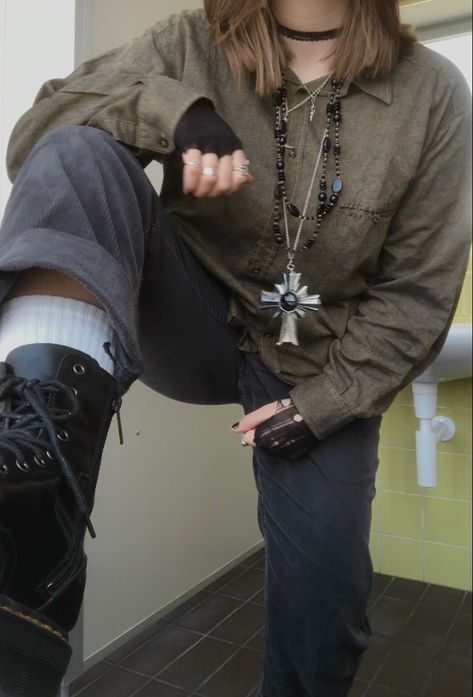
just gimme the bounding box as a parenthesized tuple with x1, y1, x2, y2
(0, 344, 120, 697)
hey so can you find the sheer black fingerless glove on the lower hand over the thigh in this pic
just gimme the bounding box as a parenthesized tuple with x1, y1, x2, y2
(255, 400, 320, 460)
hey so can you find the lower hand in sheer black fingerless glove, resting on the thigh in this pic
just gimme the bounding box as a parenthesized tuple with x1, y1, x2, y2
(234, 399, 319, 460)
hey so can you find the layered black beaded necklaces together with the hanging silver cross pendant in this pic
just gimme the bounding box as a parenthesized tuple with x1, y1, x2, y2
(260, 73, 343, 346)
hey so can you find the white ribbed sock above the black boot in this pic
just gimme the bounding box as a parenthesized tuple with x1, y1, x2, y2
(0, 295, 114, 375)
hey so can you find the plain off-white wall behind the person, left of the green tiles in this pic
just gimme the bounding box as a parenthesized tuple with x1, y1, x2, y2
(79, 0, 261, 656)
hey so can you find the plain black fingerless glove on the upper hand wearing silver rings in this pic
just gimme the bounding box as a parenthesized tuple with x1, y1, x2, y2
(174, 99, 243, 157)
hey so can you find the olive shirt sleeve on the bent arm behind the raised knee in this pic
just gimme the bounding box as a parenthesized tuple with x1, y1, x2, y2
(7, 15, 211, 181)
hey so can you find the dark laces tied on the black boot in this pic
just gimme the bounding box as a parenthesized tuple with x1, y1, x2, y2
(0, 370, 95, 537)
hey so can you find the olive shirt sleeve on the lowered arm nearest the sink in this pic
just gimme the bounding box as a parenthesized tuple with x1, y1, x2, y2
(291, 103, 471, 439)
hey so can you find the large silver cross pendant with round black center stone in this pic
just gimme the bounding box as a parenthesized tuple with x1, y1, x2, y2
(260, 271, 322, 346)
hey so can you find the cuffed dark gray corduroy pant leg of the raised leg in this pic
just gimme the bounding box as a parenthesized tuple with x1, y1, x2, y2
(0, 126, 240, 404)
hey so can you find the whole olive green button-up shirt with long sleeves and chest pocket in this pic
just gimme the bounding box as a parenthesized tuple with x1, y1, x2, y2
(8, 10, 471, 439)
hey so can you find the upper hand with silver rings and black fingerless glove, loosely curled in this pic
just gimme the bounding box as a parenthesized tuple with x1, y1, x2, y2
(174, 99, 254, 198)
